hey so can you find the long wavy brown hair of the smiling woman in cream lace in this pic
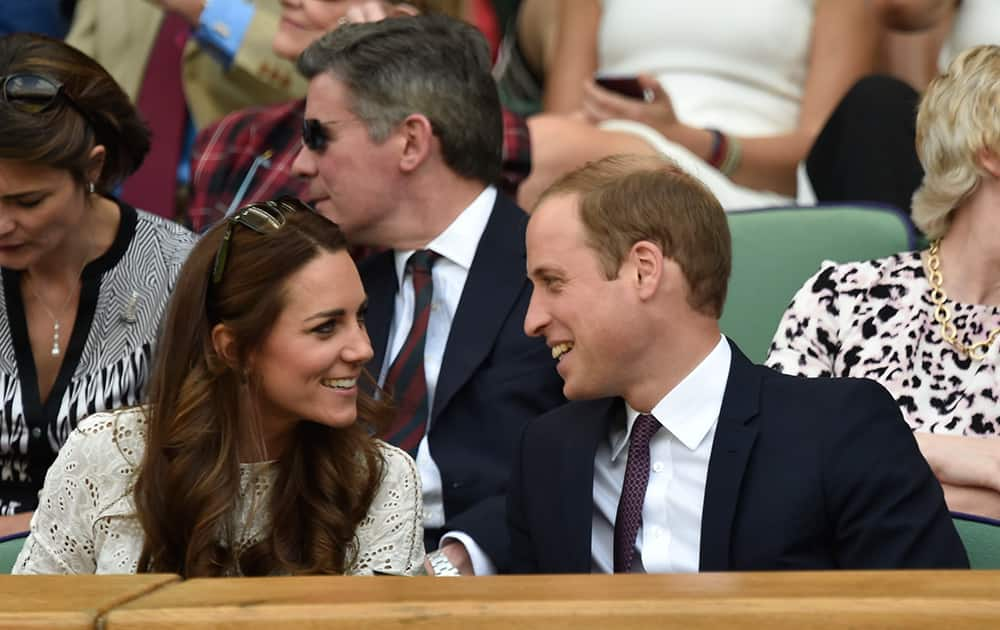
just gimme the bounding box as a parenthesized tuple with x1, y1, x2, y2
(134, 205, 385, 577)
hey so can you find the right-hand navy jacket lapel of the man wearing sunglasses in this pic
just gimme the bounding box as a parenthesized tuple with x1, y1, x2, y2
(431, 194, 528, 424)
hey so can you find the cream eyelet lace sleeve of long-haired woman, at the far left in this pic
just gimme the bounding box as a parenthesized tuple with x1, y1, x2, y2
(13, 414, 133, 574)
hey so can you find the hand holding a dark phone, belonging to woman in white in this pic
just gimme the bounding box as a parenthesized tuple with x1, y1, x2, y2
(583, 74, 679, 138)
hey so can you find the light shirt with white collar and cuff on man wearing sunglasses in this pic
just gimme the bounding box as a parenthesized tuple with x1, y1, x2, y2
(379, 186, 497, 575)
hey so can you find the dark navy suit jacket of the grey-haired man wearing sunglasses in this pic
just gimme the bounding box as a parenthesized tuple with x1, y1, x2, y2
(360, 195, 566, 570)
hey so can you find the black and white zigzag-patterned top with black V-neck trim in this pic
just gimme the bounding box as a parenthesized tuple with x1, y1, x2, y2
(0, 203, 195, 515)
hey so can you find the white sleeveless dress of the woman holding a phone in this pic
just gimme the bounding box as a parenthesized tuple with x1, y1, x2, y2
(598, 0, 815, 210)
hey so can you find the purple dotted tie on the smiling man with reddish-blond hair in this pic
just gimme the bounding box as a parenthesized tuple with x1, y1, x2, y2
(615, 413, 662, 573)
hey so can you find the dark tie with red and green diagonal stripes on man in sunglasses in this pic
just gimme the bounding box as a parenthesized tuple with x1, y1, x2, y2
(382, 249, 441, 457)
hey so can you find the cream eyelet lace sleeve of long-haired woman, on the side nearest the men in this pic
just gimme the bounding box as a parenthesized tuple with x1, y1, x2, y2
(348, 444, 424, 575)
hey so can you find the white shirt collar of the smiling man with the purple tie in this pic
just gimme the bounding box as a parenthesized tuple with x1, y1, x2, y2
(610, 336, 733, 461)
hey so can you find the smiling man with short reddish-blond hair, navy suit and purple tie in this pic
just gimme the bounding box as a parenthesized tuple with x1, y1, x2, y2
(508, 156, 968, 573)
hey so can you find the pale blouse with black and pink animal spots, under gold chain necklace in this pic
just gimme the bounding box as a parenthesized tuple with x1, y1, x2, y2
(767, 252, 1000, 436)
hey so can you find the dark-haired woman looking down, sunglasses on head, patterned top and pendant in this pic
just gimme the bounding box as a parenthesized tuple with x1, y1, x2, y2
(0, 33, 194, 535)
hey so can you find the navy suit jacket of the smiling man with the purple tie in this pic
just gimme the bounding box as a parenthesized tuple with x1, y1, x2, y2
(508, 342, 968, 573)
